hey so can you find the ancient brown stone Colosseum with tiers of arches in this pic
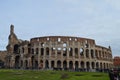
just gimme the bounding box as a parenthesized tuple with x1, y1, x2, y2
(2, 25, 113, 71)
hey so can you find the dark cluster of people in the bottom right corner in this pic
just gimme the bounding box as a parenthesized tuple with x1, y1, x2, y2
(109, 69, 120, 80)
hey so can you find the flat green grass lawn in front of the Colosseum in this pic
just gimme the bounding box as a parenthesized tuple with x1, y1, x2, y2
(0, 69, 109, 80)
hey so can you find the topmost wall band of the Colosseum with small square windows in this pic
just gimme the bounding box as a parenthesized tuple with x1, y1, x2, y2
(30, 36, 95, 47)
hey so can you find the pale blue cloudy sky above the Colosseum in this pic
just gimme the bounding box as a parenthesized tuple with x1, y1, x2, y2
(0, 0, 120, 56)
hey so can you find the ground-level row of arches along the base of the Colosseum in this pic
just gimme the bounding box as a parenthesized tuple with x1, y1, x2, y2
(15, 56, 111, 69)
